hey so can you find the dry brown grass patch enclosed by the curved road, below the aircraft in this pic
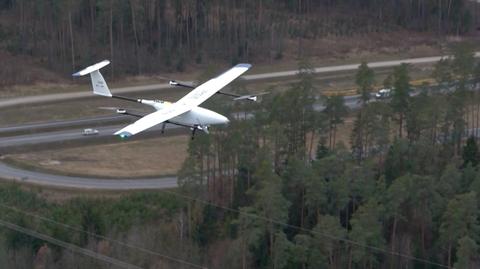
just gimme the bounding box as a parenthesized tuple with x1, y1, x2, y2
(7, 135, 190, 178)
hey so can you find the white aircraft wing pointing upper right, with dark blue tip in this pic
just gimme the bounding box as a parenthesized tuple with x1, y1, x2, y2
(176, 64, 252, 107)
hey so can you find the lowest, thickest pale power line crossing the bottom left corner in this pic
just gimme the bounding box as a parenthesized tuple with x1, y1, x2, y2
(0, 219, 142, 269)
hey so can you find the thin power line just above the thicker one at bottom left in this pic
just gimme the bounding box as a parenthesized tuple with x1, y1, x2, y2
(0, 203, 206, 269)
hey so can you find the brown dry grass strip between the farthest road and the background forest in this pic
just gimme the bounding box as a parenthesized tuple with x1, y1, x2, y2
(0, 29, 447, 98)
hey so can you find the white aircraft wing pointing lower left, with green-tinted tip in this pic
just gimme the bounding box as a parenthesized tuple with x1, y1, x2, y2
(115, 103, 192, 138)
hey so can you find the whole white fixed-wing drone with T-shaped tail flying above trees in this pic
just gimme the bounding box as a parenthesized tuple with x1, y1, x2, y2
(73, 60, 257, 139)
